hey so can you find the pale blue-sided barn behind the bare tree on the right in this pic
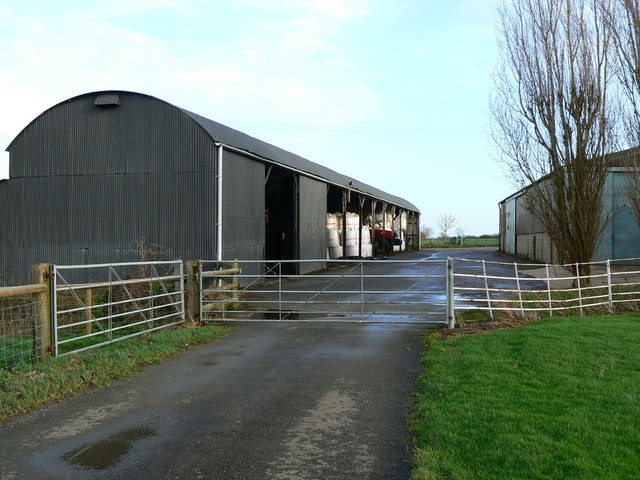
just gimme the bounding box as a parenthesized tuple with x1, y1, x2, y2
(498, 149, 640, 263)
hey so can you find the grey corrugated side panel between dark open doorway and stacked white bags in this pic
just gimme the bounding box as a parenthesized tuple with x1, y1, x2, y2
(298, 177, 327, 273)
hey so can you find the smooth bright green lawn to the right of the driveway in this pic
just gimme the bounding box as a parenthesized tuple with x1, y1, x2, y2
(412, 314, 640, 480)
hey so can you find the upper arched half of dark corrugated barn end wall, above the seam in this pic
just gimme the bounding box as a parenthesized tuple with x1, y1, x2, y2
(9, 93, 215, 178)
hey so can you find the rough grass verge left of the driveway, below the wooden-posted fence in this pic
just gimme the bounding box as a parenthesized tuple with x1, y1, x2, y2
(0, 326, 230, 422)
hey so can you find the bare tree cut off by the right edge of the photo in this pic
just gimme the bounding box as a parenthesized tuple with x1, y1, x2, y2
(603, 0, 640, 225)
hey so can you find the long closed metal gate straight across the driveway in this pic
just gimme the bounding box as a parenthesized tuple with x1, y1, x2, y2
(199, 259, 453, 324)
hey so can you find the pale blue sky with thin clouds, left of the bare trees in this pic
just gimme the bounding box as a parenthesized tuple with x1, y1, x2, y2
(0, 0, 515, 235)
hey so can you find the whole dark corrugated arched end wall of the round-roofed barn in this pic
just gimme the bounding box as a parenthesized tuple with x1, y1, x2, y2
(0, 94, 215, 282)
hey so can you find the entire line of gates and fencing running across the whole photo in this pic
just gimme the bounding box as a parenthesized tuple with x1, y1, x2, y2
(0, 258, 640, 368)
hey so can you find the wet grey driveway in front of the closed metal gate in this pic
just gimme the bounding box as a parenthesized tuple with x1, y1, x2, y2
(0, 250, 520, 480)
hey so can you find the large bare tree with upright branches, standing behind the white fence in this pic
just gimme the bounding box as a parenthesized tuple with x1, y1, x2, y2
(491, 0, 615, 273)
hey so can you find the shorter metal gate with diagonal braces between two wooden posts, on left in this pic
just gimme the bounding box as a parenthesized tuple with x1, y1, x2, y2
(51, 260, 185, 355)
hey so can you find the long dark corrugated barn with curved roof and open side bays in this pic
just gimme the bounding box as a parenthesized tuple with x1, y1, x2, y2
(0, 91, 420, 283)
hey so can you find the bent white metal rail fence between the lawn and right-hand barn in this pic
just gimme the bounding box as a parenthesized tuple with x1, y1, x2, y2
(453, 258, 640, 318)
